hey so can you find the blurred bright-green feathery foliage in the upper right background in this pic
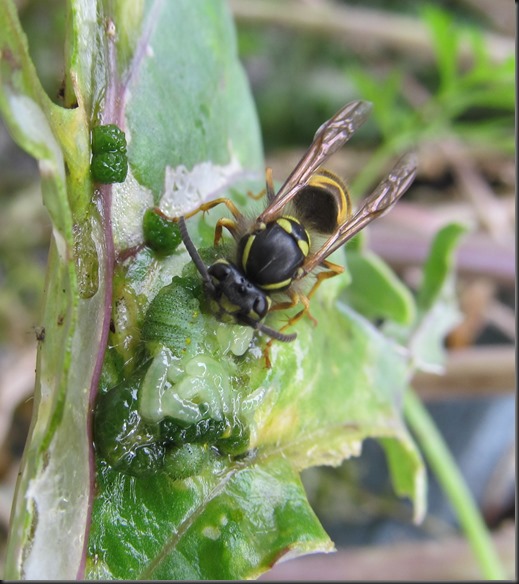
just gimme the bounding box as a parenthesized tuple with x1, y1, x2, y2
(239, 1, 515, 191)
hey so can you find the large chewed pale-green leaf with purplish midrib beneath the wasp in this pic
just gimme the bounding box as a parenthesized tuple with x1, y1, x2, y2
(0, 0, 424, 579)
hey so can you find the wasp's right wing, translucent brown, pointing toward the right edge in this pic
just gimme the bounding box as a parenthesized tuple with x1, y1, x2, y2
(300, 153, 417, 278)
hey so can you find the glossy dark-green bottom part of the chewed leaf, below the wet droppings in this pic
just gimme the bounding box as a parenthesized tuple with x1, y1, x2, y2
(88, 457, 332, 580)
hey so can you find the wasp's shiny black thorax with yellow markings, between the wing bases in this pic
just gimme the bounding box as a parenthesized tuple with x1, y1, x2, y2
(238, 217, 310, 291)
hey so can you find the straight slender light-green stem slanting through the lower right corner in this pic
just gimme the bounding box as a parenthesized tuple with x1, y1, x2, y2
(404, 390, 506, 580)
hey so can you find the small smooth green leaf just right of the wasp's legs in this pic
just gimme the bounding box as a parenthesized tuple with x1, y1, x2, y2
(344, 248, 416, 324)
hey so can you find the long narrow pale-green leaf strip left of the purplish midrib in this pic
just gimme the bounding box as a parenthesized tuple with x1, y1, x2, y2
(0, 0, 96, 579)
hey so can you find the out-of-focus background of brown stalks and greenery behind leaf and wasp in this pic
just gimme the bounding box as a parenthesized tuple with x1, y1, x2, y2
(0, 0, 516, 580)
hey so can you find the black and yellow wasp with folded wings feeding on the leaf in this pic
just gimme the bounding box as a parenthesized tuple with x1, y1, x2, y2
(178, 101, 416, 362)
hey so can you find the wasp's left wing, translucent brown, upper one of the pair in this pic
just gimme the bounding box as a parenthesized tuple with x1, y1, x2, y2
(257, 101, 371, 223)
